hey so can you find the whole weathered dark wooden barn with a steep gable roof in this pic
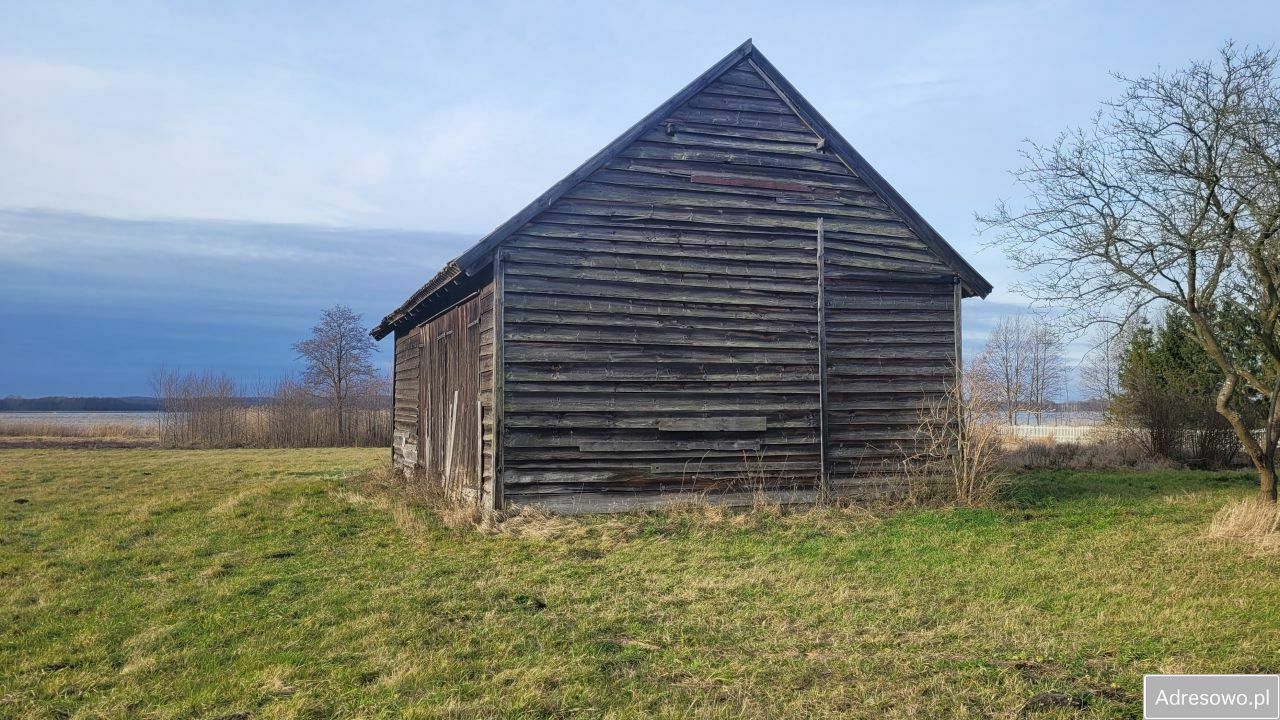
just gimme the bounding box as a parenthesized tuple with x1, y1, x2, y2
(372, 41, 991, 511)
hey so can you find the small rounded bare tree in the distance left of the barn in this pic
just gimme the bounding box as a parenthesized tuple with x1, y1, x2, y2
(293, 305, 378, 438)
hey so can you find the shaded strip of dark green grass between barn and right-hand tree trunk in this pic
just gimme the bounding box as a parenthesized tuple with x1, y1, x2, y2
(1001, 470, 1258, 507)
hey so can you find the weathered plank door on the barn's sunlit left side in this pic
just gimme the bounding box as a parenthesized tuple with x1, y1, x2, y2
(419, 292, 480, 501)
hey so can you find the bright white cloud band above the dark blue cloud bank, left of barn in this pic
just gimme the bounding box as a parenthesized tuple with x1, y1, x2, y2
(0, 59, 603, 232)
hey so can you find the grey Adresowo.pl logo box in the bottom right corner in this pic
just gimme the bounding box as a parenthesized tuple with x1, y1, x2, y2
(1142, 675, 1280, 720)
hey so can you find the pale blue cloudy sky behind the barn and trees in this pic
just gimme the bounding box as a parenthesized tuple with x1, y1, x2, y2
(0, 0, 1280, 397)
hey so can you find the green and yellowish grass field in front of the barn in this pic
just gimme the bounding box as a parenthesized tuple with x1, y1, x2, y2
(0, 450, 1280, 720)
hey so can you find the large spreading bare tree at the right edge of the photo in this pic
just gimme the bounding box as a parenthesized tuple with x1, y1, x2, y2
(978, 44, 1280, 502)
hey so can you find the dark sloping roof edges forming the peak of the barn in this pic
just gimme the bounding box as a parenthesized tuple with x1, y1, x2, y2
(370, 40, 992, 340)
